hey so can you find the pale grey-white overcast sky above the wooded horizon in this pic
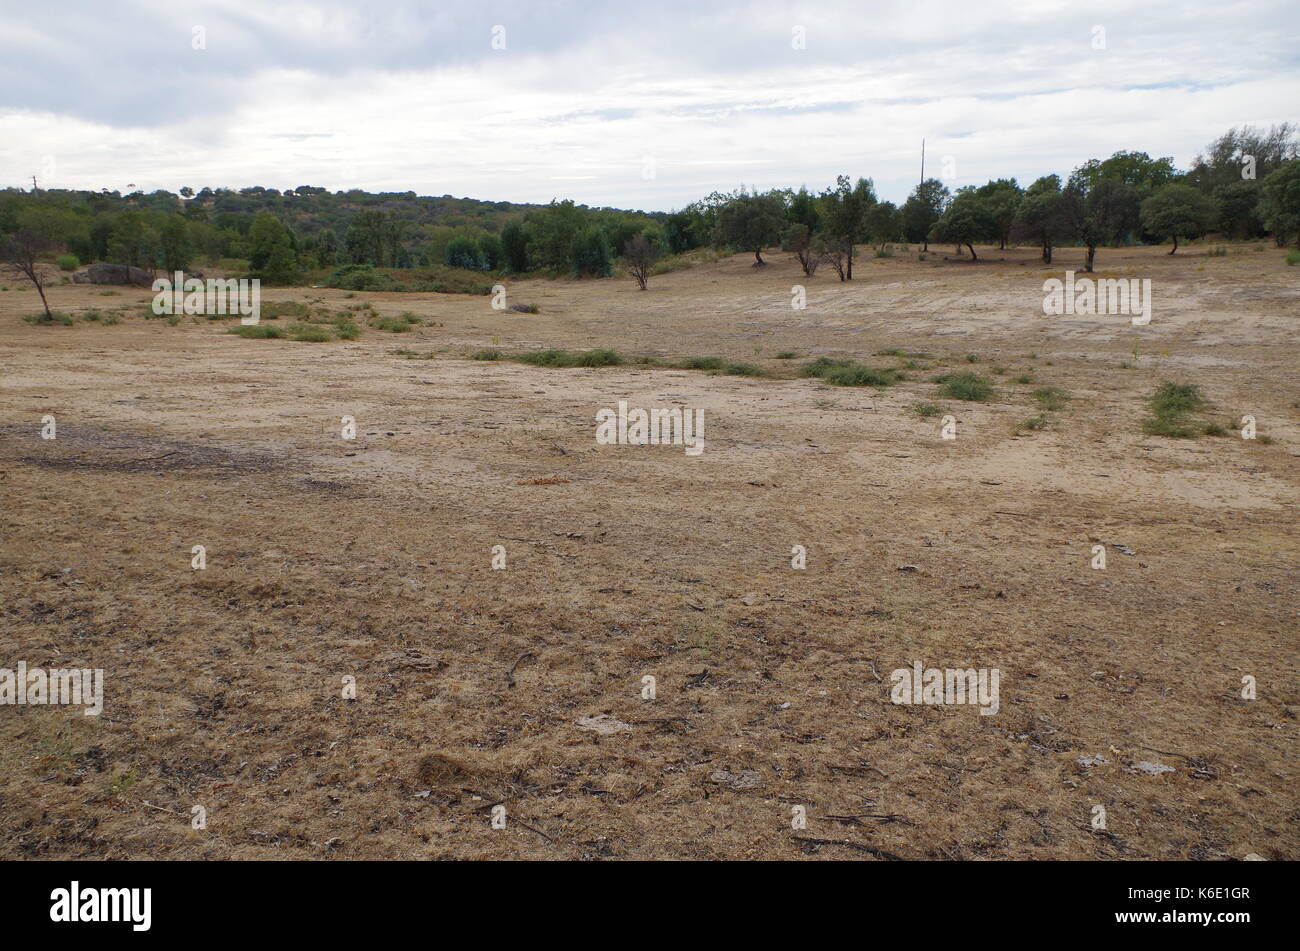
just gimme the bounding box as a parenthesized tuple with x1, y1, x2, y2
(0, 0, 1300, 210)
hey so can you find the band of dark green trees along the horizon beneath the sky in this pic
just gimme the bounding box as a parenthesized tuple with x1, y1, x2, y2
(0, 123, 1300, 287)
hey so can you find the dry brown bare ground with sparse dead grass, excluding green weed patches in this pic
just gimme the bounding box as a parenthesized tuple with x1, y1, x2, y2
(0, 246, 1300, 859)
